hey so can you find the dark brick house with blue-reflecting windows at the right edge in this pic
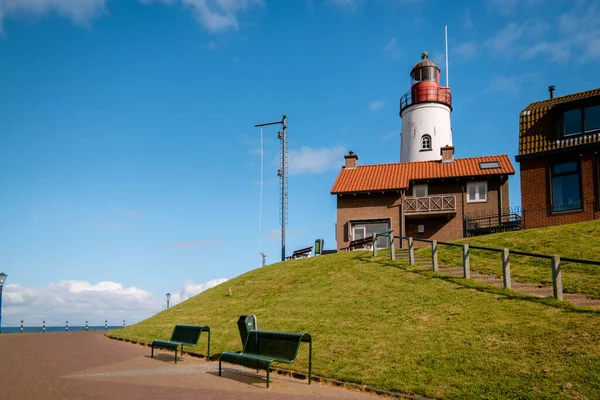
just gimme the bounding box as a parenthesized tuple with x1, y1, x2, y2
(515, 86, 600, 228)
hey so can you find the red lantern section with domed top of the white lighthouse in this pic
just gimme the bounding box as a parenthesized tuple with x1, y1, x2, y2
(400, 51, 452, 116)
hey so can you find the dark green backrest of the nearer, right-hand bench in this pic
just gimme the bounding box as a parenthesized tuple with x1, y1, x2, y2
(243, 330, 311, 363)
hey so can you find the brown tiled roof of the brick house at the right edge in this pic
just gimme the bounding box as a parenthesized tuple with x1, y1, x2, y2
(519, 88, 600, 155)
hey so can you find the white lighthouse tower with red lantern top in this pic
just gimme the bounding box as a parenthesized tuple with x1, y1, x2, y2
(400, 52, 452, 162)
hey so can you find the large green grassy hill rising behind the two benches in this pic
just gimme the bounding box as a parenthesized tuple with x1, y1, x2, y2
(111, 223, 600, 399)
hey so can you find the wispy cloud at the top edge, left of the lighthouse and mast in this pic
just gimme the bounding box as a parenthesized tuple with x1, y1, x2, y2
(138, 0, 265, 33)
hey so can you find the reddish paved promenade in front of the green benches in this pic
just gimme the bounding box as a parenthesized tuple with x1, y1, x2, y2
(0, 332, 382, 400)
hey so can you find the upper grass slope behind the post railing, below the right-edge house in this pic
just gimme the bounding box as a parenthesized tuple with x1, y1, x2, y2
(418, 220, 600, 298)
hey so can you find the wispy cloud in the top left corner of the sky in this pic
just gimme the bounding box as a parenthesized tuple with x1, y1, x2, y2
(0, 0, 106, 27)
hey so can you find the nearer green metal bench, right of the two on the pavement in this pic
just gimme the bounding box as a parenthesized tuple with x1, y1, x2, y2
(219, 330, 312, 388)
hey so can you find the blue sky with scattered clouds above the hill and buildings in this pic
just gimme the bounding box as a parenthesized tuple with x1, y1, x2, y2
(0, 0, 600, 324)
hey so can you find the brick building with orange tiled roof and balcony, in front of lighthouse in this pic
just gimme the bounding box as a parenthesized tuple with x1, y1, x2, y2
(331, 147, 515, 249)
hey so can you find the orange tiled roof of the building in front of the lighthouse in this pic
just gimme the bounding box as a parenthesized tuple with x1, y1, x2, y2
(331, 154, 515, 194)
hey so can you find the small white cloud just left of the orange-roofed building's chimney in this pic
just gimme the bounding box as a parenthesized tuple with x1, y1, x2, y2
(288, 146, 345, 175)
